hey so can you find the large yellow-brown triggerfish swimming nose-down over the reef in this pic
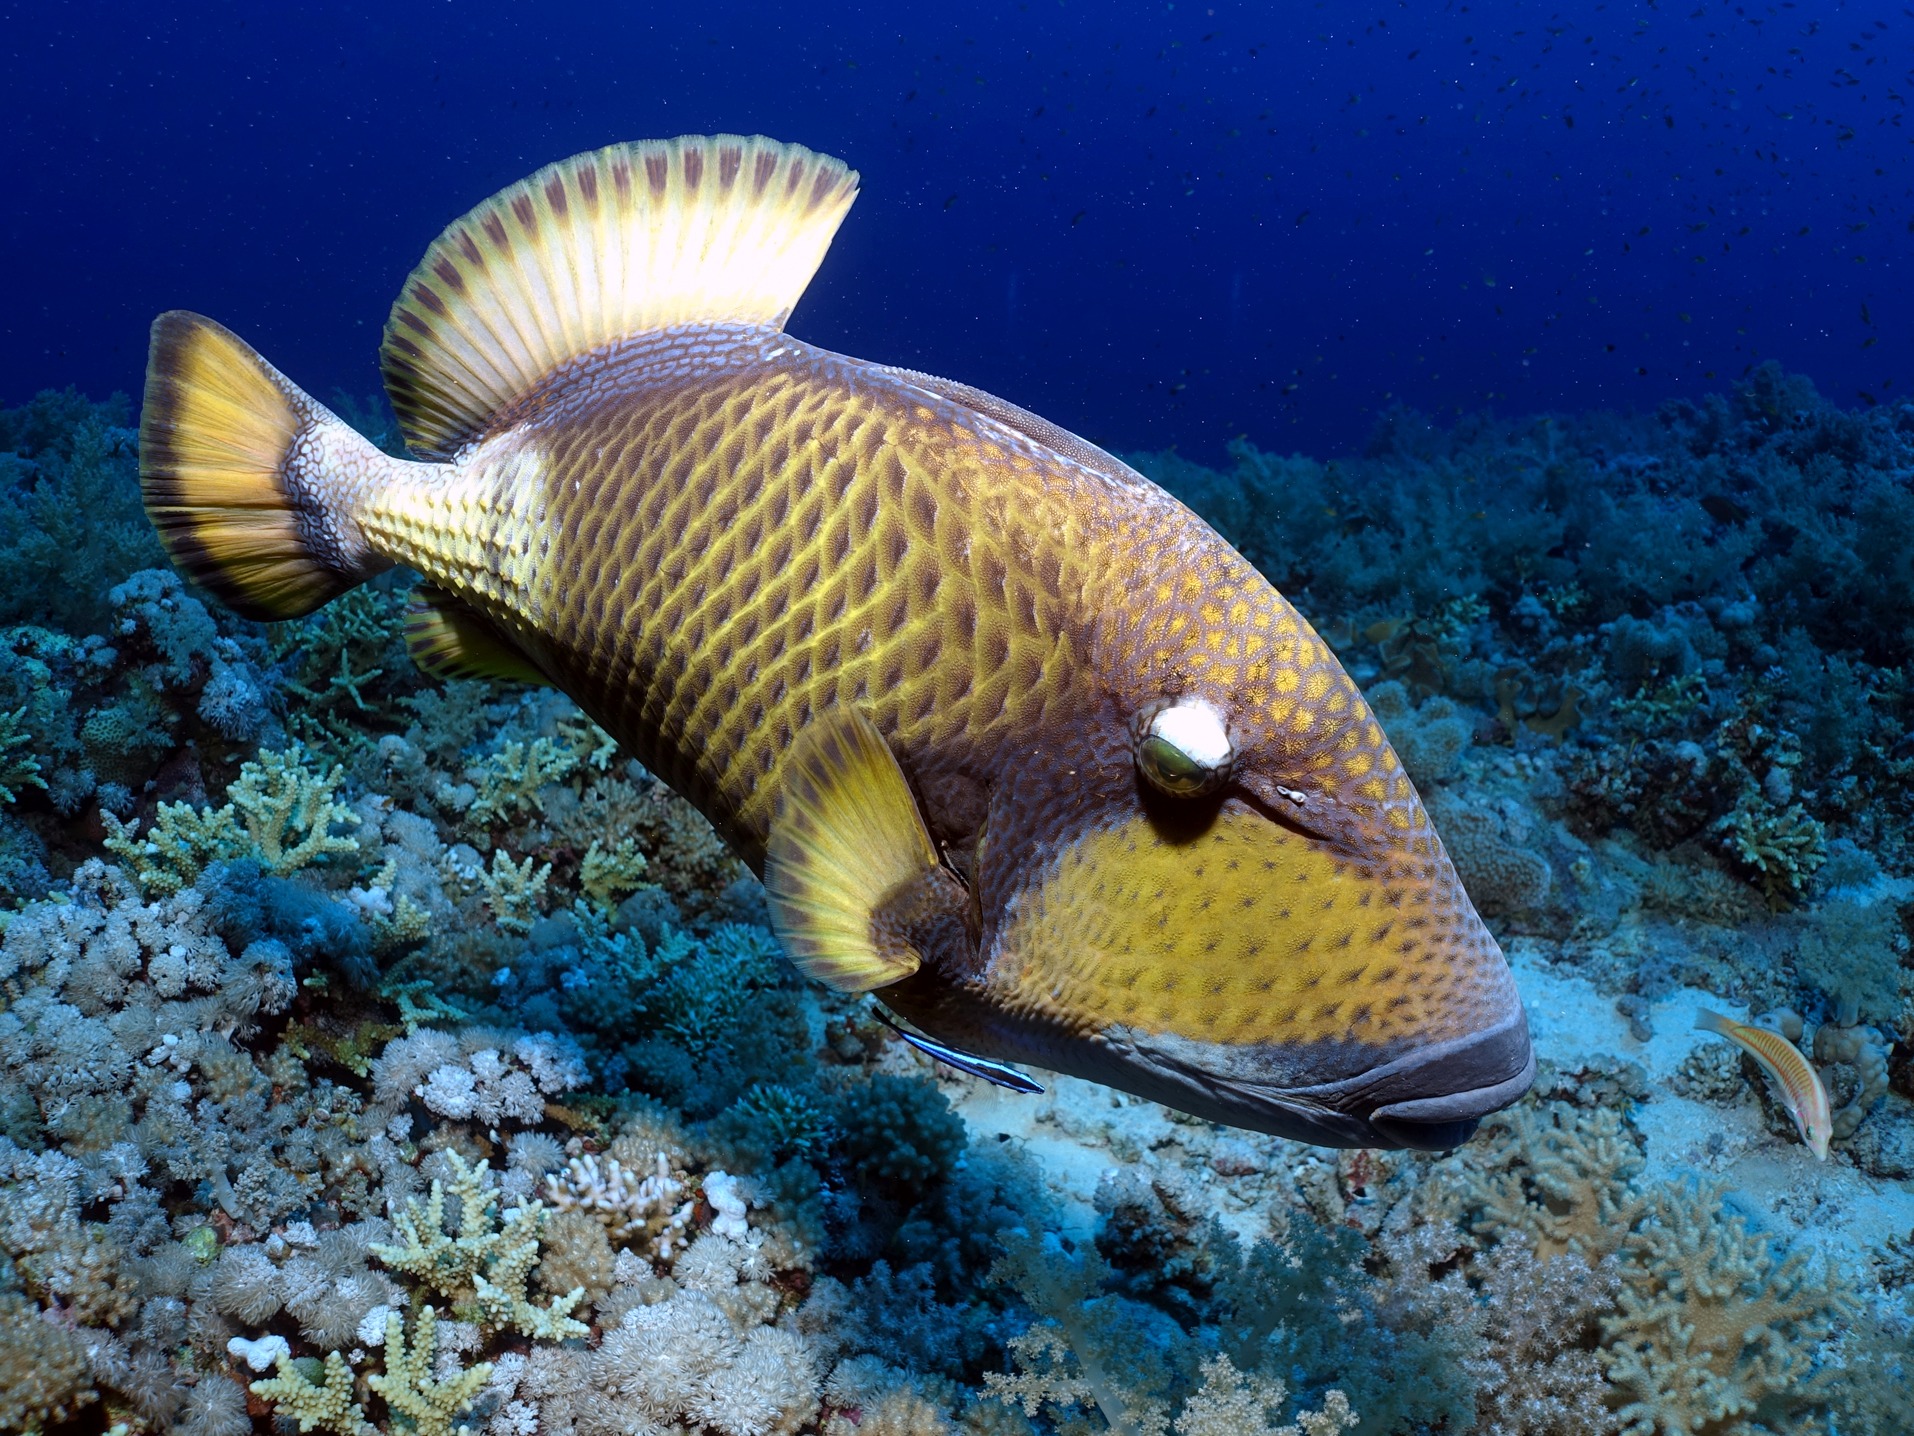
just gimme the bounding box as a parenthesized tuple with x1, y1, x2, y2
(140, 136, 1535, 1149)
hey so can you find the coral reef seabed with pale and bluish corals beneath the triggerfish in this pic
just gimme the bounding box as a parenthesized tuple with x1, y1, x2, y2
(0, 370, 1914, 1436)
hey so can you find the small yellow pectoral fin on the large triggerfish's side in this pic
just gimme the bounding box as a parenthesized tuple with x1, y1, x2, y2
(764, 708, 942, 992)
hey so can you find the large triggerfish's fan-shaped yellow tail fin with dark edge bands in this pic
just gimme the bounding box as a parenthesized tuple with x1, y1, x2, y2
(140, 310, 404, 620)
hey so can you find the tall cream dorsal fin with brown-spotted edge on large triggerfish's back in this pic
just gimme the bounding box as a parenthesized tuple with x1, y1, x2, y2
(379, 134, 857, 460)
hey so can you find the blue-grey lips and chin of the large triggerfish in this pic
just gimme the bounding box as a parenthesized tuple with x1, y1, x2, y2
(1118, 1003, 1535, 1151)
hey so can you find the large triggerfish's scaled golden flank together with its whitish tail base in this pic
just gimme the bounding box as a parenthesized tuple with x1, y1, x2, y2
(362, 331, 1101, 865)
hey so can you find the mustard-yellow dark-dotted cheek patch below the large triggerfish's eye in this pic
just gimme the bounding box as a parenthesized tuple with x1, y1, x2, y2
(1007, 812, 1504, 1045)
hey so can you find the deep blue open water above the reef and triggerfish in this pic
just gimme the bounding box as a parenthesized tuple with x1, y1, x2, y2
(0, 0, 1914, 456)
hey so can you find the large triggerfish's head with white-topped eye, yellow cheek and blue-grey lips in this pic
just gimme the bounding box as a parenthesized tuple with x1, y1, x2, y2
(957, 612, 1535, 1149)
